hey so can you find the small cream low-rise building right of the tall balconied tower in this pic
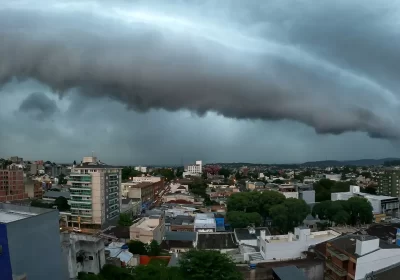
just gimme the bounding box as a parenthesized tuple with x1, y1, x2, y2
(129, 215, 165, 244)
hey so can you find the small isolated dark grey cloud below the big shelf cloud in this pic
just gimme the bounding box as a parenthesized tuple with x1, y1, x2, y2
(18, 92, 58, 121)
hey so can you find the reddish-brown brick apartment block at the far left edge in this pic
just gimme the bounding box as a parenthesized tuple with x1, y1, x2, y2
(0, 166, 28, 202)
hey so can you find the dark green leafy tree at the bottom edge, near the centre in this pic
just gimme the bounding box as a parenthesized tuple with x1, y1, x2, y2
(179, 250, 243, 280)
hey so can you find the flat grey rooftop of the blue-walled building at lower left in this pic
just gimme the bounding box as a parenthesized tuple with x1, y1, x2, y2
(0, 203, 55, 224)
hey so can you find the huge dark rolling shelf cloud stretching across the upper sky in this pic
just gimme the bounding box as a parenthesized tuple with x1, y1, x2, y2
(0, 0, 400, 139)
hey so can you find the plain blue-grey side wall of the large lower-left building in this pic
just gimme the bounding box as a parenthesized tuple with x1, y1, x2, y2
(7, 211, 68, 280)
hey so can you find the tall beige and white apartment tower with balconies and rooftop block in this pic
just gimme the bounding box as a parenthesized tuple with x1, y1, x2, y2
(68, 157, 122, 228)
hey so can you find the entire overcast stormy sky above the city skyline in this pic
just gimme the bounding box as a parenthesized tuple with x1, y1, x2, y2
(0, 0, 400, 165)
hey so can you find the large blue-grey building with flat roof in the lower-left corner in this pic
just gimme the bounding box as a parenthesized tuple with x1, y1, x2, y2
(0, 203, 69, 280)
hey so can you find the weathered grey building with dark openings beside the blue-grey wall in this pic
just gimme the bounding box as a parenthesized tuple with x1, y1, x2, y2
(61, 232, 106, 279)
